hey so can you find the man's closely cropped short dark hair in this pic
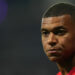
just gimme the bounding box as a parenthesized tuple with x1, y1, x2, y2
(42, 3, 75, 19)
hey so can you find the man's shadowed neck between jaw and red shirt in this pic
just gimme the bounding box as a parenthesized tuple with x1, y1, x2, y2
(57, 56, 75, 75)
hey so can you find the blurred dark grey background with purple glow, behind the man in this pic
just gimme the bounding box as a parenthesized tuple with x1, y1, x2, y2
(0, 0, 75, 75)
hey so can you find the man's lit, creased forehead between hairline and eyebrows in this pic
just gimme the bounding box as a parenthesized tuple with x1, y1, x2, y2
(41, 14, 72, 28)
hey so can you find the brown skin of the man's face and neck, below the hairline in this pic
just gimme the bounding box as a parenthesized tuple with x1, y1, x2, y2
(41, 14, 75, 75)
